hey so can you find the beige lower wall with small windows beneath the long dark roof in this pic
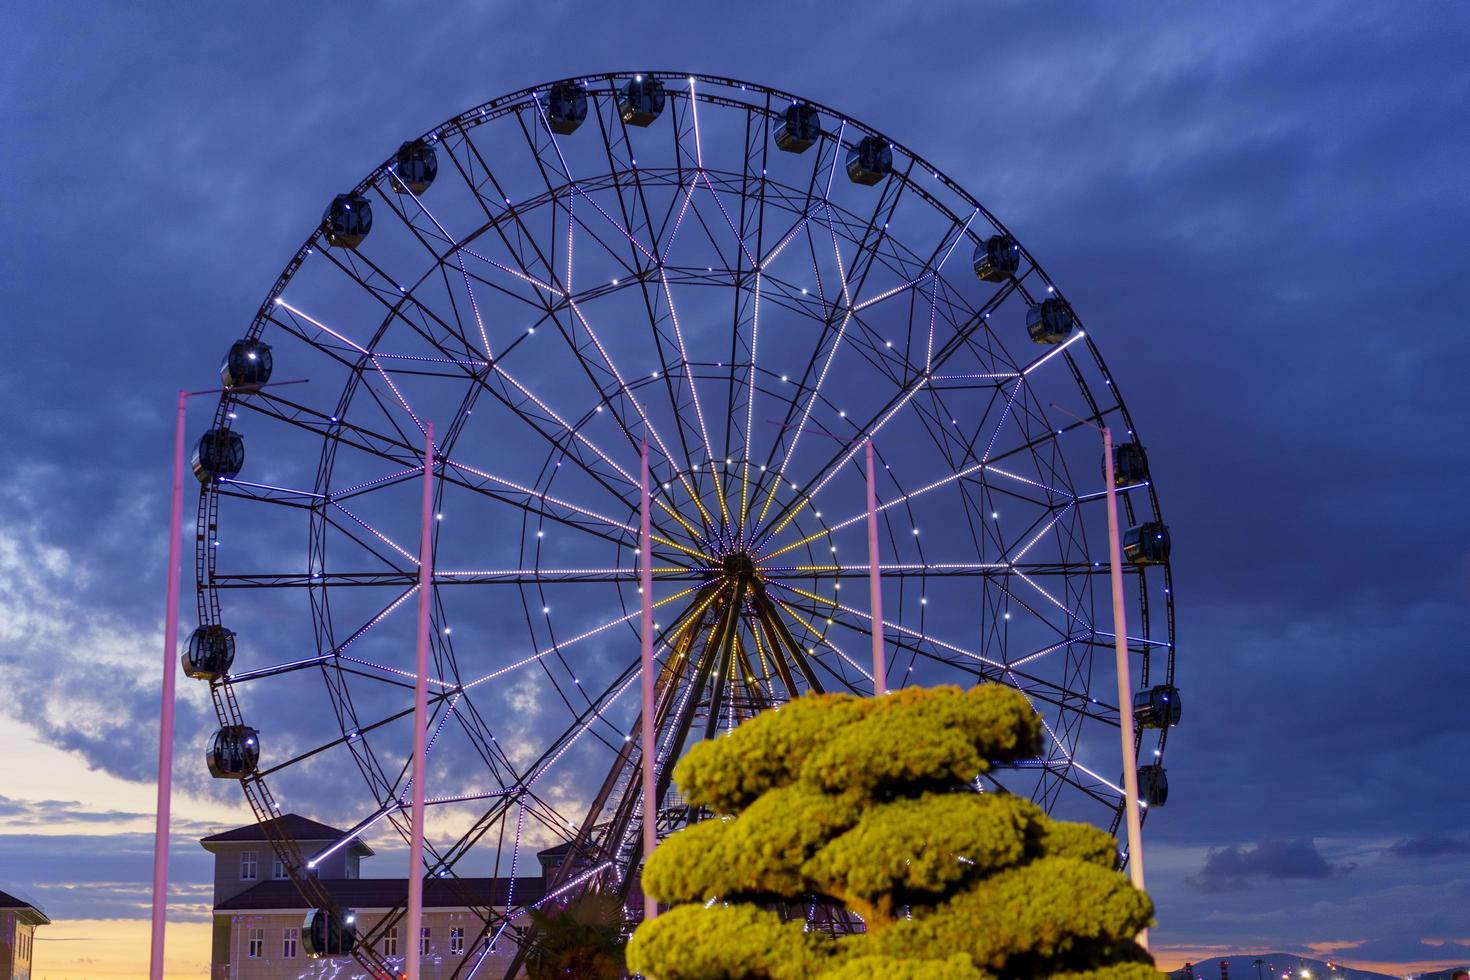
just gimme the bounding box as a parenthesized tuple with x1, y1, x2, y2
(214, 908, 516, 980)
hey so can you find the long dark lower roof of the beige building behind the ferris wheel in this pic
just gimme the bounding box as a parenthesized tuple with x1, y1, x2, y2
(223, 877, 547, 912)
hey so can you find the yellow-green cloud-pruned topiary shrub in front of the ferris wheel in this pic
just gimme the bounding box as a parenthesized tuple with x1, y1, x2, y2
(628, 685, 1161, 980)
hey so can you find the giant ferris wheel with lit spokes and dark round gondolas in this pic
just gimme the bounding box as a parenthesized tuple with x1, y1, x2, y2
(184, 72, 1179, 976)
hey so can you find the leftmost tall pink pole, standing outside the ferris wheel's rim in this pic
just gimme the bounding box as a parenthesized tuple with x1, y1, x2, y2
(148, 391, 188, 980)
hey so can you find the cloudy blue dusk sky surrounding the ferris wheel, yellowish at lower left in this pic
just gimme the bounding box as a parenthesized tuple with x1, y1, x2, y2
(0, 1, 1470, 979)
